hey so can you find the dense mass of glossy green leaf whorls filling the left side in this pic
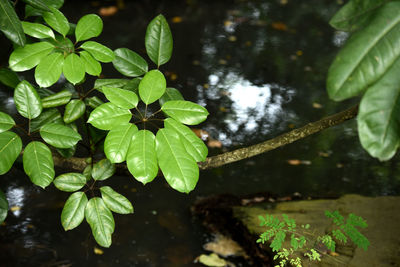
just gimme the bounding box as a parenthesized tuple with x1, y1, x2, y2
(0, 0, 208, 247)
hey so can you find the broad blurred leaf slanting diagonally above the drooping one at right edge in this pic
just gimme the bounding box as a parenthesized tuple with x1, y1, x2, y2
(327, 1, 400, 101)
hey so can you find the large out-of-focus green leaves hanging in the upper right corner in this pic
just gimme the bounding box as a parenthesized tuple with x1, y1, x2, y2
(327, 0, 400, 160)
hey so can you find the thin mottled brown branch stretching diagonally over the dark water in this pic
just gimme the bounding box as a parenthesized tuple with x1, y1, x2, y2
(53, 105, 358, 171)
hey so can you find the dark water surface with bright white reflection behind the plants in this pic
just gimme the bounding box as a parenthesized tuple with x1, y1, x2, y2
(0, 0, 400, 266)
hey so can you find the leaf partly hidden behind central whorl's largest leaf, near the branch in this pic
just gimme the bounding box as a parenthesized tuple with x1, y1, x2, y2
(164, 118, 208, 161)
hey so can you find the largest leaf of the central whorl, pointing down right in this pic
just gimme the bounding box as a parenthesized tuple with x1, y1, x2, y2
(156, 129, 199, 193)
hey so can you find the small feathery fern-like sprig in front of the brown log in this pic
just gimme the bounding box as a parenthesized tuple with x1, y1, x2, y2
(257, 211, 369, 267)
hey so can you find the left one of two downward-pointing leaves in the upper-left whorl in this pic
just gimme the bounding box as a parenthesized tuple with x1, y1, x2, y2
(35, 53, 64, 87)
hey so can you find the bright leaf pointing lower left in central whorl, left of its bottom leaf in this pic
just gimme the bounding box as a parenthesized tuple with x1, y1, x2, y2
(104, 123, 138, 163)
